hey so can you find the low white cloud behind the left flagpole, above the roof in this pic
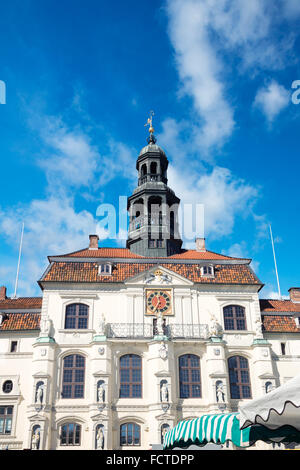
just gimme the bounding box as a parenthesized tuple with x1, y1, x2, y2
(0, 196, 103, 295)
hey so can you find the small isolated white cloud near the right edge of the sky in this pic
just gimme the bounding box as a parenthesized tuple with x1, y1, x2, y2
(254, 80, 290, 123)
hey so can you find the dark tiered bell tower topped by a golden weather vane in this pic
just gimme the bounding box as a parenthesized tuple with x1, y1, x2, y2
(126, 112, 182, 258)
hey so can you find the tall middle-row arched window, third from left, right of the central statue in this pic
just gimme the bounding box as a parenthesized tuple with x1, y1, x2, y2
(179, 354, 201, 398)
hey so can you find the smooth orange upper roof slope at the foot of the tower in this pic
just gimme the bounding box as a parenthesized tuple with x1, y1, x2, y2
(53, 248, 250, 261)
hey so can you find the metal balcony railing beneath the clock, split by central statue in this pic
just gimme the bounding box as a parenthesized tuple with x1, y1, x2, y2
(106, 323, 208, 340)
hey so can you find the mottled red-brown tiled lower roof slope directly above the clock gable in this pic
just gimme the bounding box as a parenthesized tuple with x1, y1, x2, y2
(41, 261, 261, 285)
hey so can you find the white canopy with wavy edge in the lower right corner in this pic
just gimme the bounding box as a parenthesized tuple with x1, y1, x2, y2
(239, 375, 300, 431)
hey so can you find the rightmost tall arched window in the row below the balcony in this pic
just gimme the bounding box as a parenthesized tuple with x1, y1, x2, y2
(228, 356, 251, 399)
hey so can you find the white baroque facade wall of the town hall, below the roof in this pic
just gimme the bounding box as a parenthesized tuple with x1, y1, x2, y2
(0, 253, 300, 450)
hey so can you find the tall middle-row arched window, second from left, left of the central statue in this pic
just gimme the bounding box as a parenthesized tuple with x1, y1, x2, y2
(120, 354, 142, 398)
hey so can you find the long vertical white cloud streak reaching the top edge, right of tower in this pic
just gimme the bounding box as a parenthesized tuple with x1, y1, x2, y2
(167, 1, 234, 149)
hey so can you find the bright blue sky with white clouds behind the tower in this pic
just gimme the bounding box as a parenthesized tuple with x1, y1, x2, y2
(0, 0, 300, 297)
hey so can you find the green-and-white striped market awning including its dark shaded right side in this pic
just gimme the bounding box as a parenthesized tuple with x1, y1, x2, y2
(163, 413, 300, 449)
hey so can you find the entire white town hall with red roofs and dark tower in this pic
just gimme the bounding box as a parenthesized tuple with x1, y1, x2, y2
(0, 128, 300, 450)
